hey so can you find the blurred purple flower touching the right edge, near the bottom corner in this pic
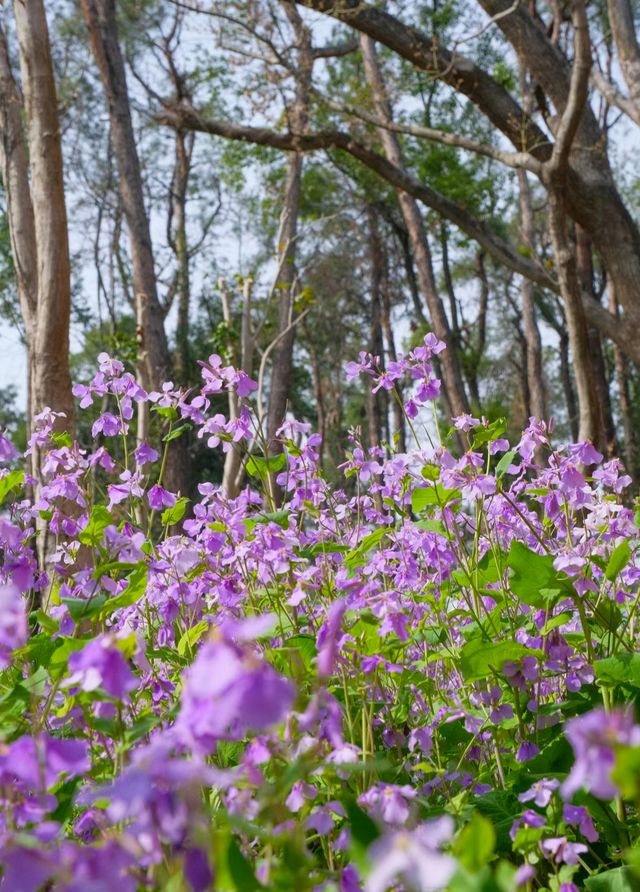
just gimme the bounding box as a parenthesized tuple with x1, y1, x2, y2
(562, 709, 640, 799)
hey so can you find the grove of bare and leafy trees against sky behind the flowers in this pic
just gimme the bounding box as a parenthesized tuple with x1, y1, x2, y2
(0, 0, 640, 492)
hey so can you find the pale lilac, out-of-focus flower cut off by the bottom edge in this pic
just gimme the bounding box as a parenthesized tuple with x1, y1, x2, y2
(364, 815, 456, 892)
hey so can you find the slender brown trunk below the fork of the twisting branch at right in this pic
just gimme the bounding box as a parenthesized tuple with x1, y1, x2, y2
(549, 189, 605, 448)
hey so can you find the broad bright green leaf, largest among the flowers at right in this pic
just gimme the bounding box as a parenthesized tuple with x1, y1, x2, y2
(507, 540, 575, 608)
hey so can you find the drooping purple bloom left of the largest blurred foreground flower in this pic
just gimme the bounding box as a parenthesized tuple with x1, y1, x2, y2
(65, 634, 136, 700)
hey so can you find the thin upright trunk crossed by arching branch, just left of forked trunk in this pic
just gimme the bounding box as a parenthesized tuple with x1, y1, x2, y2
(518, 170, 547, 420)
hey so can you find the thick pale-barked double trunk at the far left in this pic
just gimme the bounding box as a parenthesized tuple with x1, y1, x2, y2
(8, 0, 74, 434)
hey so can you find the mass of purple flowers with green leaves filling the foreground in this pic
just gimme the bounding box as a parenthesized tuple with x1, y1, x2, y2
(0, 344, 640, 892)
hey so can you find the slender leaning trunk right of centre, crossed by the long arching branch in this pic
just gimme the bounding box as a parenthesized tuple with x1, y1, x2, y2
(360, 34, 469, 415)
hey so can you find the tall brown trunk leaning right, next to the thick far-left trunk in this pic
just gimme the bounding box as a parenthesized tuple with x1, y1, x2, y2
(81, 0, 189, 493)
